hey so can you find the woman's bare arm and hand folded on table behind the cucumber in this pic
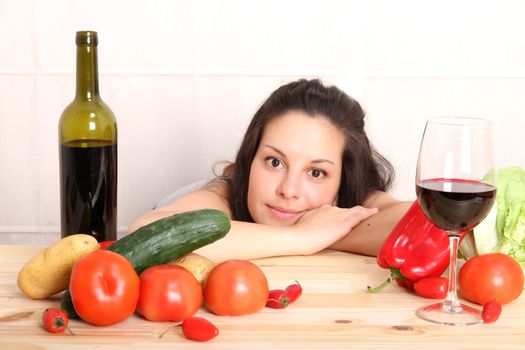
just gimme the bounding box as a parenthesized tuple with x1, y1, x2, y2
(128, 186, 377, 262)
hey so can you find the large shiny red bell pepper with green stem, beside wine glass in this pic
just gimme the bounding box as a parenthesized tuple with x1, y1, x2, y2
(368, 201, 450, 292)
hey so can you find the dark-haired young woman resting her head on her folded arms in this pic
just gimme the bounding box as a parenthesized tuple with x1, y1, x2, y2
(129, 79, 411, 262)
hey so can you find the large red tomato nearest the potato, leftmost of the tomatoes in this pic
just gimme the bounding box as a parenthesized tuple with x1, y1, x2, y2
(69, 250, 140, 326)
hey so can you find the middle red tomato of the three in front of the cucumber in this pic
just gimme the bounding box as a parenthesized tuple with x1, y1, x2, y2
(137, 265, 202, 321)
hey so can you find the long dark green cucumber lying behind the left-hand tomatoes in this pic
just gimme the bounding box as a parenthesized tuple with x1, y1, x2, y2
(107, 209, 231, 275)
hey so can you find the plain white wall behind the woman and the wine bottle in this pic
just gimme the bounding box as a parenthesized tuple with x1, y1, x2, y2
(0, 0, 525, 241)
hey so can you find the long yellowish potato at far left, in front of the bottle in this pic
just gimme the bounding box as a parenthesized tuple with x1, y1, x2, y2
(17, 234, 99, 299)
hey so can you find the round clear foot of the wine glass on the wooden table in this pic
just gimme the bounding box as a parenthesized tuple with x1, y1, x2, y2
(416, 303, 483, 326)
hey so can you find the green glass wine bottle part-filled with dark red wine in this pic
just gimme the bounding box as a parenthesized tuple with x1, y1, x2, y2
(58, 31, 117, 242)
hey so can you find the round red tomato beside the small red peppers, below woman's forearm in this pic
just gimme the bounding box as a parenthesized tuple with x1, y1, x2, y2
(204, 260, 268, 316)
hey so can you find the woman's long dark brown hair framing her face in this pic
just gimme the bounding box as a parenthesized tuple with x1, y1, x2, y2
(224, 79, 394, 222)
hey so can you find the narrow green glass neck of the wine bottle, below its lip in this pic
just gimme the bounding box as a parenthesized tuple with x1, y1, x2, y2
(75, 44, 99, 101)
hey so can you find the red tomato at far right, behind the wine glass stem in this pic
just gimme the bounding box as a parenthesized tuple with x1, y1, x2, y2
(459, 253, 524, 305)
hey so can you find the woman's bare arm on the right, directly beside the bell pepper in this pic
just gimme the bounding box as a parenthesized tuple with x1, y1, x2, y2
(330, 191, 412, 256)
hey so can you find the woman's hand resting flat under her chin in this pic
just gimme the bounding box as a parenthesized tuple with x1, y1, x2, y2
(292, 204, 378, 255)
